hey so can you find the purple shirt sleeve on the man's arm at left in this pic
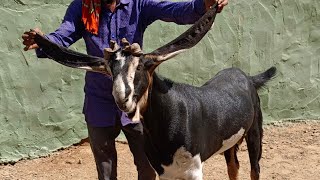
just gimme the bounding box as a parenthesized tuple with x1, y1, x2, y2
(36, 0, 84, 58)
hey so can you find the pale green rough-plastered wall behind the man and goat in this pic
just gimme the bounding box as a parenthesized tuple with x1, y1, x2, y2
(0, 0, 320, 163)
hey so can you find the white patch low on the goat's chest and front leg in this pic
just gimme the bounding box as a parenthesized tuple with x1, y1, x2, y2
(159, 147, 202, 180)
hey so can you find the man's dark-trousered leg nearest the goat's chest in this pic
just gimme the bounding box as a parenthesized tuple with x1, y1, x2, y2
(122, 123, 156, 180)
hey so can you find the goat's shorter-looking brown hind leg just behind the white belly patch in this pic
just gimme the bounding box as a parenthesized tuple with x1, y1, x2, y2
(224, 144, 240, 180)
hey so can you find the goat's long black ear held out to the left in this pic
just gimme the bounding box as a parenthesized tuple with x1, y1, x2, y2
(34, 33, 111, 74)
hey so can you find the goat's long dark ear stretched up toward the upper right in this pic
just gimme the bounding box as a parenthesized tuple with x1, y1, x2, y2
(144, 3, 218, 63)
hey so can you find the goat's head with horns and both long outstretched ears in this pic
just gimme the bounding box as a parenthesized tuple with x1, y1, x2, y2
(35, 5, 217, 121)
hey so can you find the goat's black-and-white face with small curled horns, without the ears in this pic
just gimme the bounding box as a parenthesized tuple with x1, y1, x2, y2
(104, 39, 154, 121)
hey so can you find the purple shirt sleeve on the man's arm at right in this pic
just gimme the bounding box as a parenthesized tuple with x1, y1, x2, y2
(141, 0, 206, 24)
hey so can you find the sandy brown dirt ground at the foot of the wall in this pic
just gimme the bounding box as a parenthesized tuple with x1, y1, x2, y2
(0, 121, 320, 180)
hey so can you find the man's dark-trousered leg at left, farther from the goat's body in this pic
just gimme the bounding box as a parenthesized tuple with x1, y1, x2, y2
(87, 124, 121, 180)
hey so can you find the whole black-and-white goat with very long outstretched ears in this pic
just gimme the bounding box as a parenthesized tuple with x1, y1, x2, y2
(35, 6, 276, 180)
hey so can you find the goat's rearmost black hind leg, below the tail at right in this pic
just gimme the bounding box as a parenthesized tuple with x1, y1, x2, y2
(246, 109, 263, 180)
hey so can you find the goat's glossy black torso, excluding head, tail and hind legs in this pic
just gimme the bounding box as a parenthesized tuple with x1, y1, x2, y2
(144, 68, 270, 179)
